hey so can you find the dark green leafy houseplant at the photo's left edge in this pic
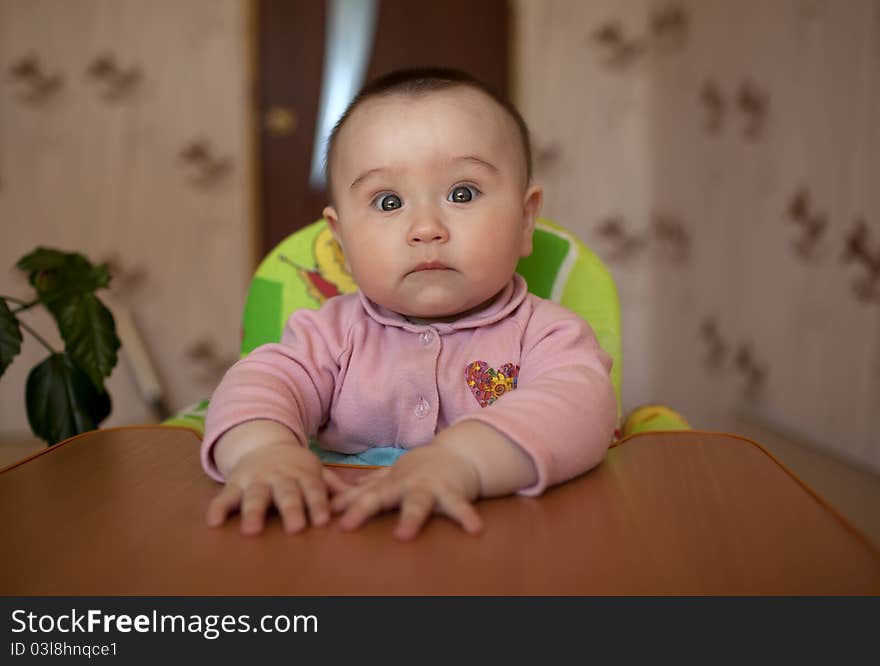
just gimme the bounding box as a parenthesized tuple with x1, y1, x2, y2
(0, 247, 120, 446)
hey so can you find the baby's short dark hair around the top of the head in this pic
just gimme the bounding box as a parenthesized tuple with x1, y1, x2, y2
(324, 67, 532, 204)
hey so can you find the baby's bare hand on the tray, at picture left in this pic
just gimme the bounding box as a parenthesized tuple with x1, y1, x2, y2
(207, 431, 349, 534)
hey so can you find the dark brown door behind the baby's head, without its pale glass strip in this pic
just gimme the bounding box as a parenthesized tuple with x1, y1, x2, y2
(256, 0, 509, 255)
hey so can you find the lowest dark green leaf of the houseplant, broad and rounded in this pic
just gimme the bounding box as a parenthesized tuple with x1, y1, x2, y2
(25, 354, 111, 445)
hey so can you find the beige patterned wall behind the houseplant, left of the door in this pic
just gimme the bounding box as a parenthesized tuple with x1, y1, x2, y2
(0, 0, 255, 435)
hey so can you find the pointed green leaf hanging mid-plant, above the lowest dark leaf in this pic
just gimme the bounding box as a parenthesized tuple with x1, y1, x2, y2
(46, 293, 120, 391)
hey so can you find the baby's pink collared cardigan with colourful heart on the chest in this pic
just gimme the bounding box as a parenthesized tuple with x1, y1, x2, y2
(202, 275, 617, 495)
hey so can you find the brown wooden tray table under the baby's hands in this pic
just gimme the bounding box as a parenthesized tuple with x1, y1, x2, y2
(0, 426, 880, 596)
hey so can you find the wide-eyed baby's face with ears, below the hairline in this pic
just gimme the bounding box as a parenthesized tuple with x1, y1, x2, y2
(324, 87, 542, 320)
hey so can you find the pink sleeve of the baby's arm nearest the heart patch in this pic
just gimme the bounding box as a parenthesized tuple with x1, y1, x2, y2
(464, 301, 617, 495)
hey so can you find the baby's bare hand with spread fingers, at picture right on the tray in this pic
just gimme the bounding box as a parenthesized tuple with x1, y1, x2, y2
(331, 443, 483, 539)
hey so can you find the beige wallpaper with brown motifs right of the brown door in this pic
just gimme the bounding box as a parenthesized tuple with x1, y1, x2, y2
(515, 0, 880, 470)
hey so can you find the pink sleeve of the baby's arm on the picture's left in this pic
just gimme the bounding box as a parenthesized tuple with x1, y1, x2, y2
(201, 298, 347, 481)
